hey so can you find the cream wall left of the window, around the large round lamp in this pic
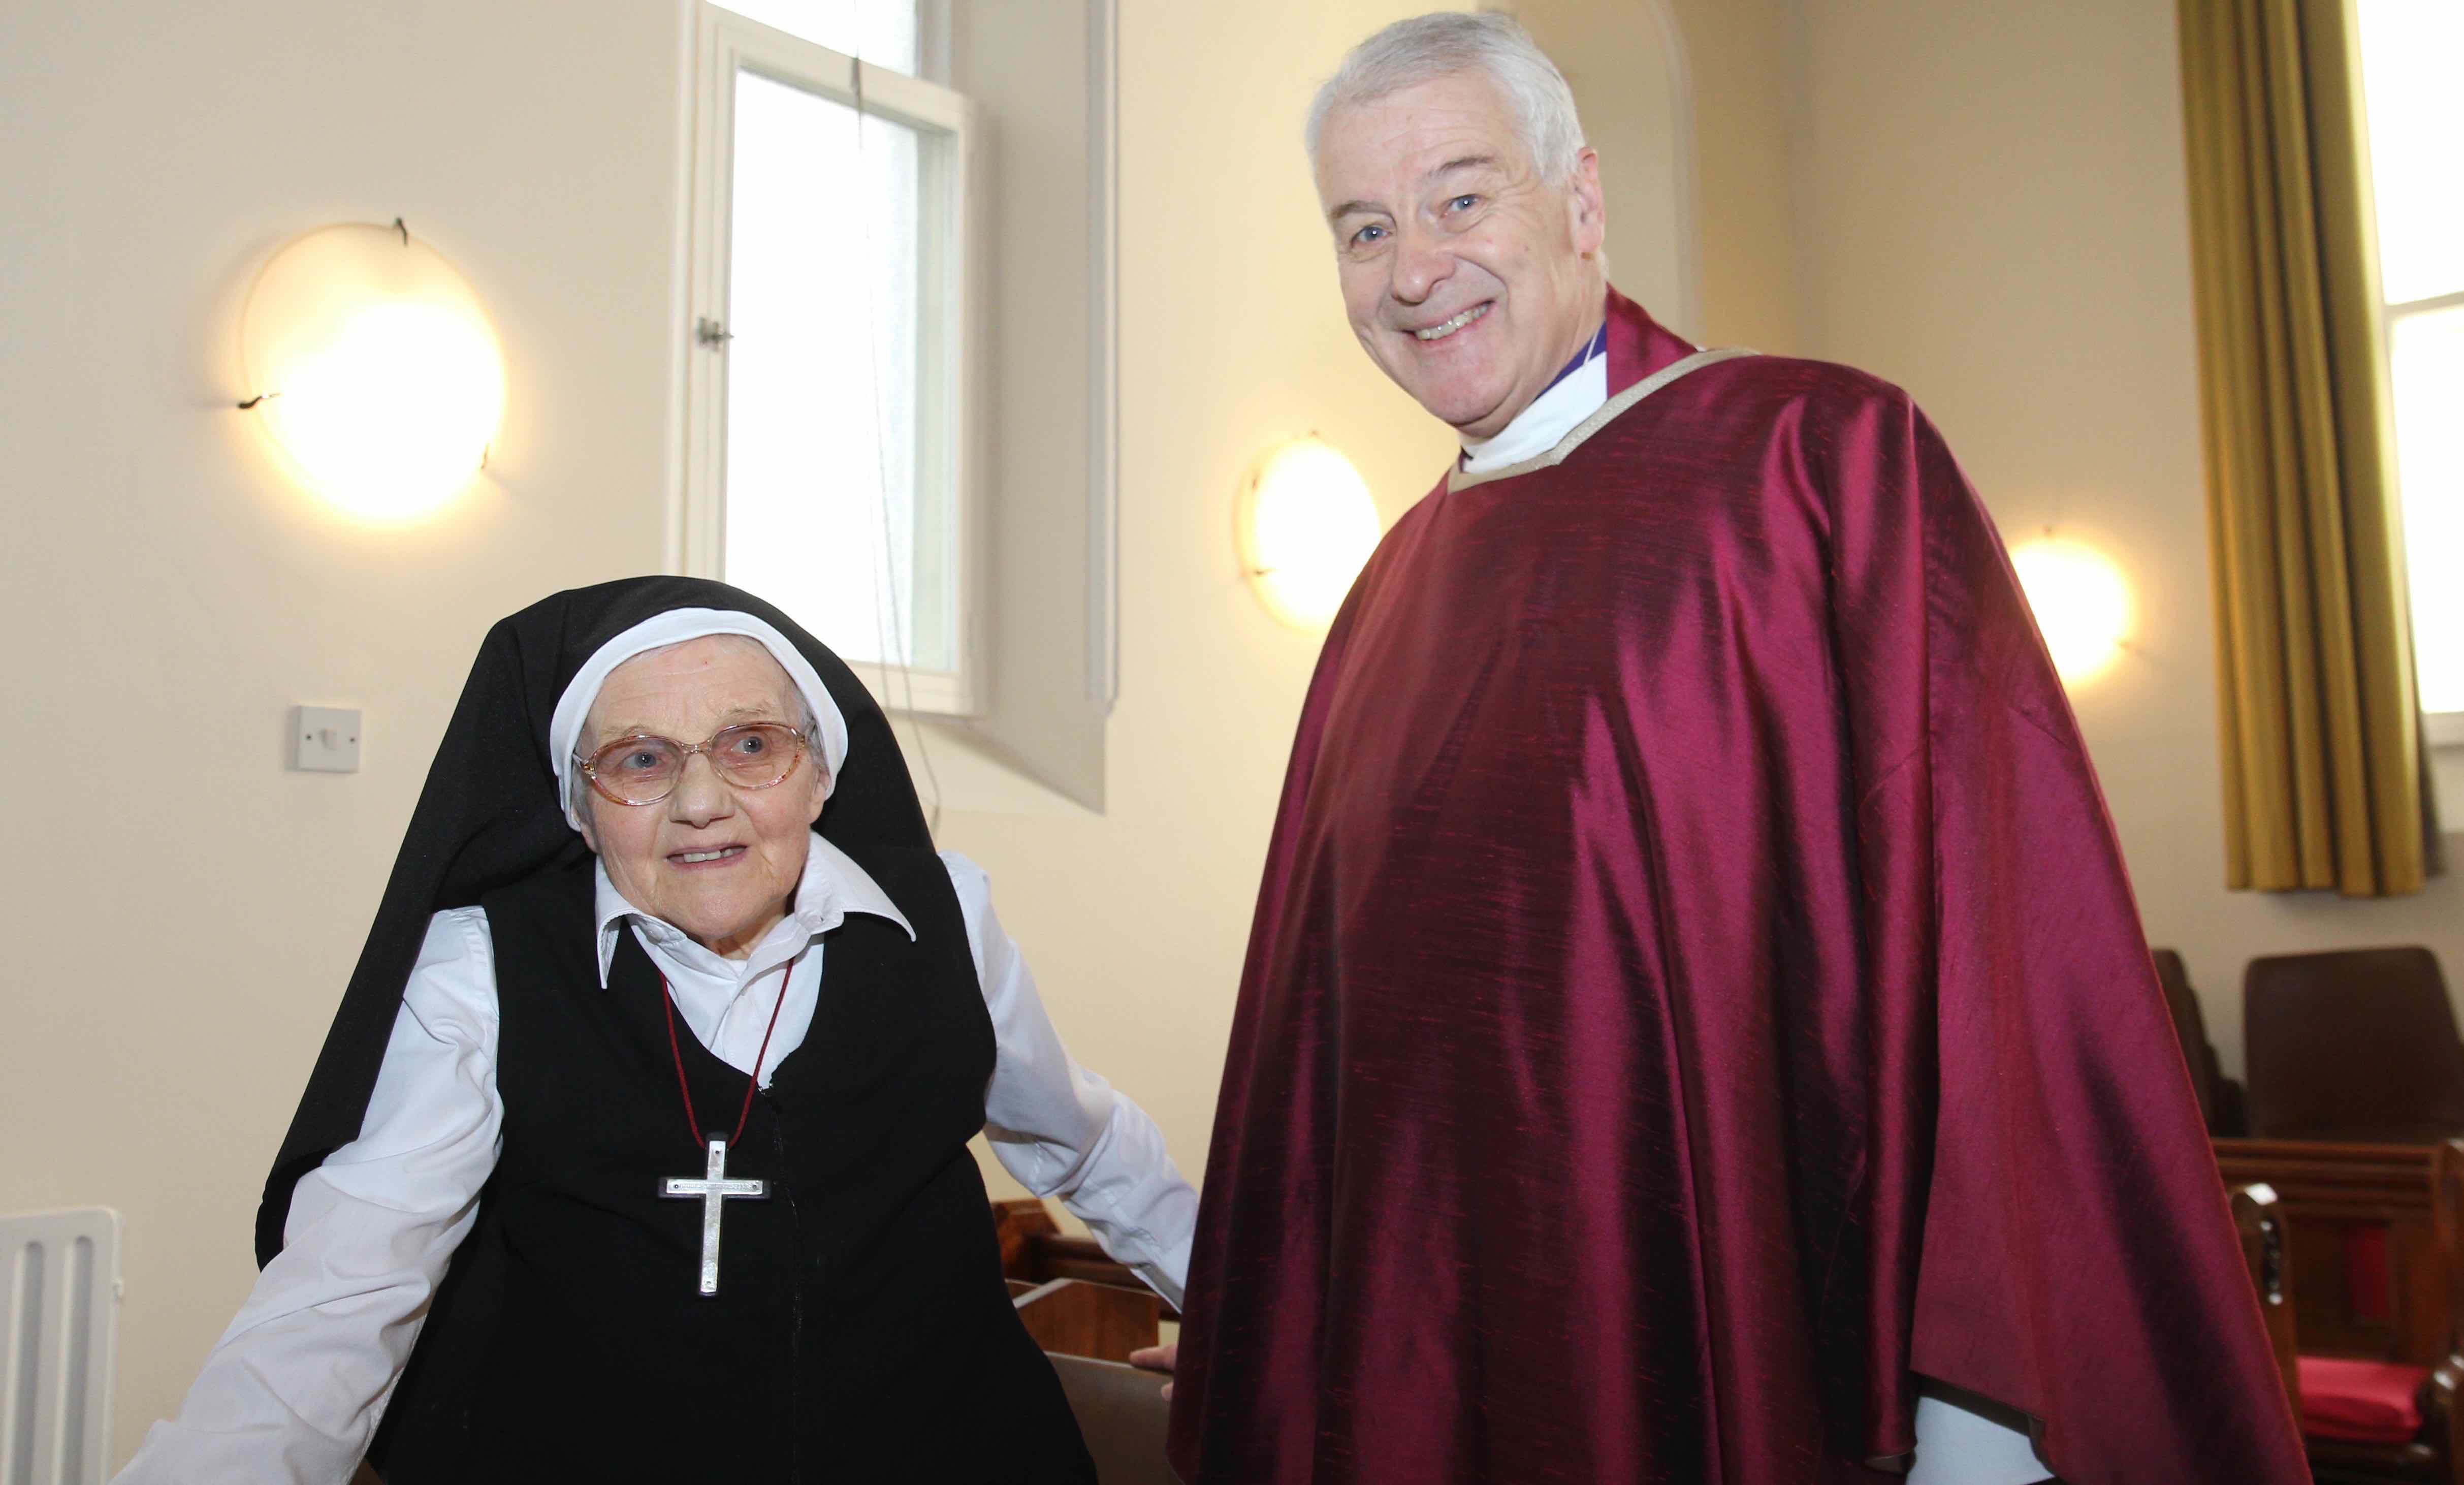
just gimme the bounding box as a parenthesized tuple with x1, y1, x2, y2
(0, 0, 680, 1461)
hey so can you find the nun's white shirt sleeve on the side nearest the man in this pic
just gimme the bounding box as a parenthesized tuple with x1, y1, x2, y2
(941, 849, 1198, 1308)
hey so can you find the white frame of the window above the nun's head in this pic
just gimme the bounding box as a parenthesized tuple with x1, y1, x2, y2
(680, 0, 988, 717)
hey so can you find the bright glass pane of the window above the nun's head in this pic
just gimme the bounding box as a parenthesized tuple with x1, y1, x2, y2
(724, 72, 953, 670)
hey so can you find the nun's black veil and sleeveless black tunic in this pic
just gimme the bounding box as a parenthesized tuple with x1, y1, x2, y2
(257, 576, 1092, 1485)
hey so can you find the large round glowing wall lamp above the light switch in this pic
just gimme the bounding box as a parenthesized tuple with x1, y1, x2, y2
(239, 217, 505, 522)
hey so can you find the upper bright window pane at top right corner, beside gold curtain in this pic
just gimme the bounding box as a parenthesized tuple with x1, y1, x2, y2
(2360, 0, 2464, 303)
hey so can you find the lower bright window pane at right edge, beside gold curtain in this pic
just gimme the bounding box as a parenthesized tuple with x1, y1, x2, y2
(2388, 305, 2464, 712)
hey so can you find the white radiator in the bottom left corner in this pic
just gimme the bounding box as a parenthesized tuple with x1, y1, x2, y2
(0, 1207, 121, 1485)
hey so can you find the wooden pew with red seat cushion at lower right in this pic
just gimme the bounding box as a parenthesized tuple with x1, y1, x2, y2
(2215, 1140, 2464, 1485)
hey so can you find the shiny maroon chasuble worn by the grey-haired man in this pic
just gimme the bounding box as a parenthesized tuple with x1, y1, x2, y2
(1170, 293, 2309, 1485)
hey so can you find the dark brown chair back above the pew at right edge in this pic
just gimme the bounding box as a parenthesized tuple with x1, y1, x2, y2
(2242, 945, 2464, 1145)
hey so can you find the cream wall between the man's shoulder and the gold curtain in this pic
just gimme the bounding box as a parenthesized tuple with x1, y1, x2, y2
(1799, 0, 2464, 1069)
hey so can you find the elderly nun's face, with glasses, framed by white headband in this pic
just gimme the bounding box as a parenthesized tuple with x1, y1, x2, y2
(579, 636, 823, 958)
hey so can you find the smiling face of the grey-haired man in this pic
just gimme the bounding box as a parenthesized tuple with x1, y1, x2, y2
(1318, 72, 1607, 438)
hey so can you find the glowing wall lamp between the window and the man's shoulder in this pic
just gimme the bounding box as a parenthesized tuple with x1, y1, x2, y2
(1239, 436, 1380, 633)
